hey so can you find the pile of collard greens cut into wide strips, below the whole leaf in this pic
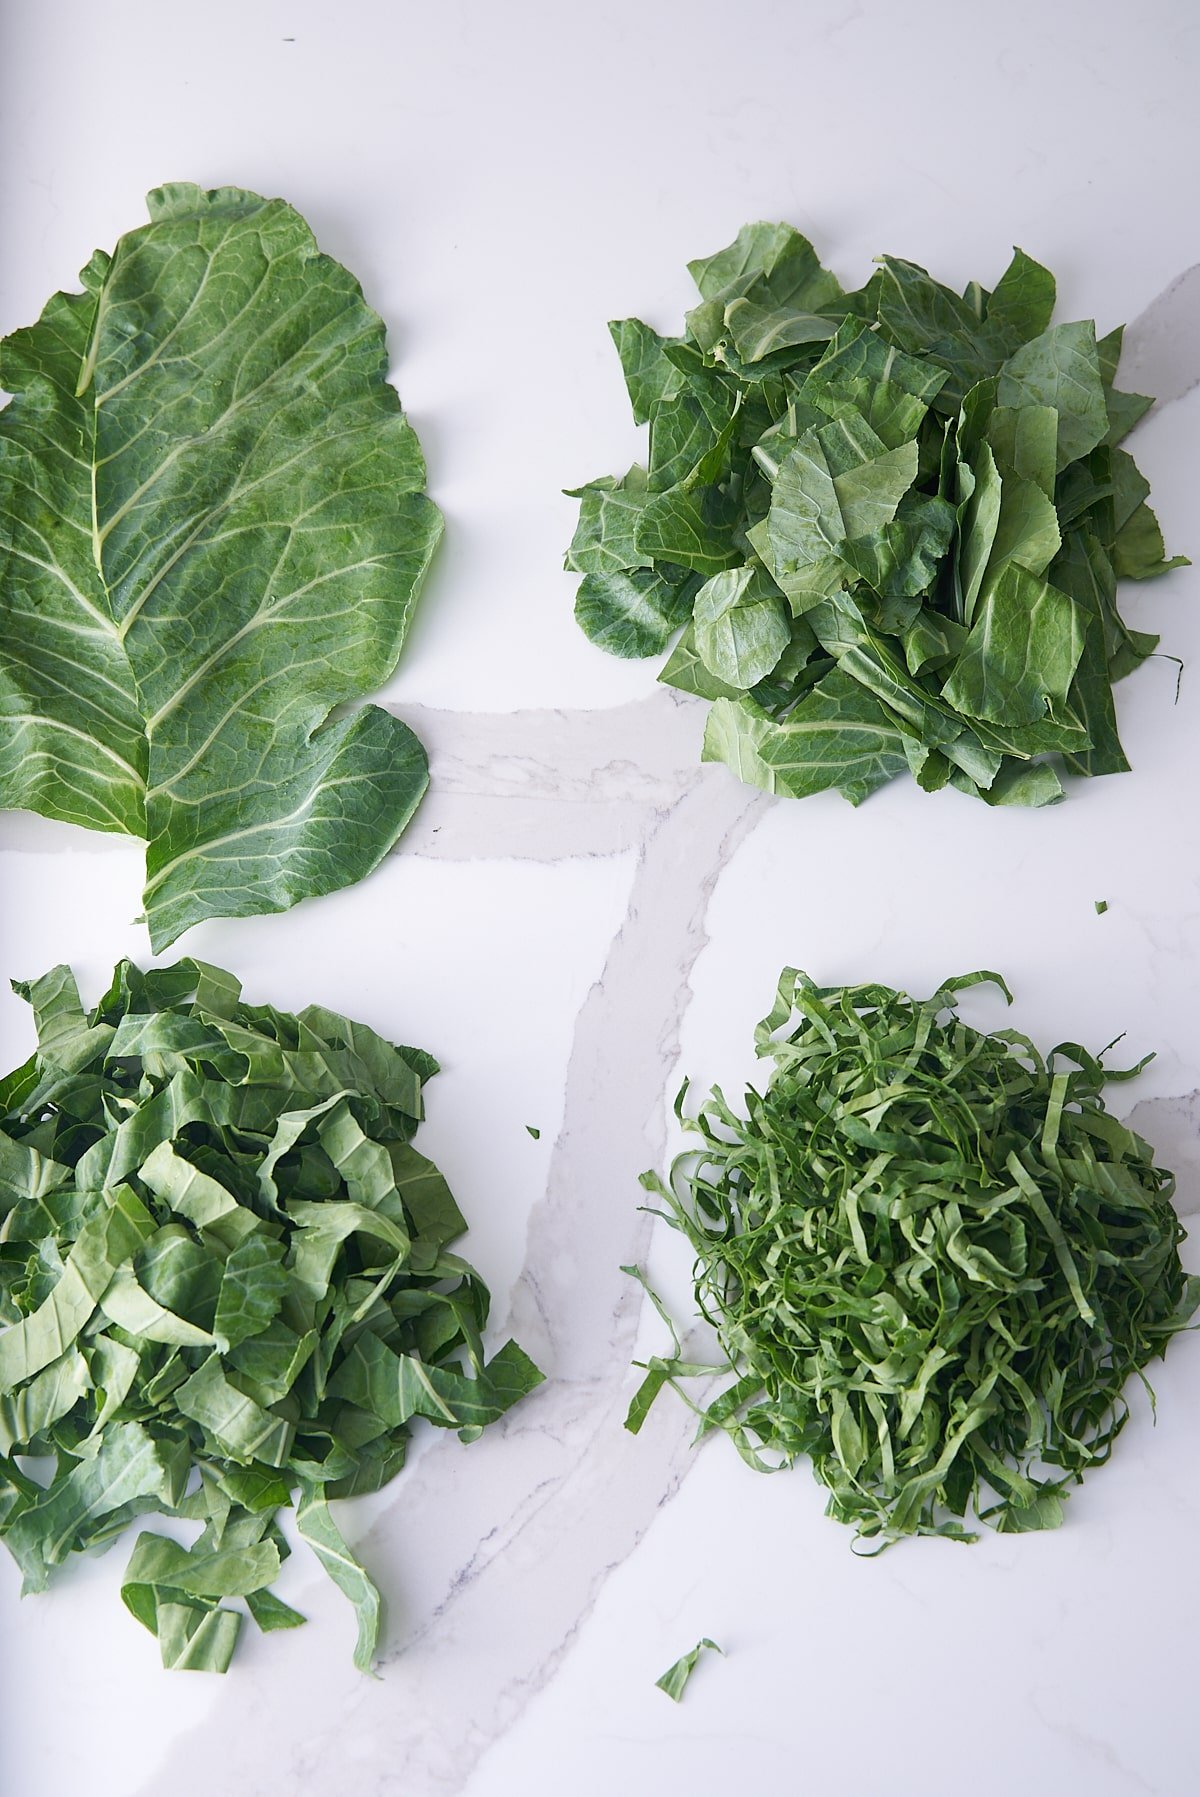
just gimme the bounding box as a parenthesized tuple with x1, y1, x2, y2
(0, 961, 541, 1671)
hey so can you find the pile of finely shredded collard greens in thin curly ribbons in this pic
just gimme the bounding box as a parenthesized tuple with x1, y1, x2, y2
(627, 969, 1200, 1545)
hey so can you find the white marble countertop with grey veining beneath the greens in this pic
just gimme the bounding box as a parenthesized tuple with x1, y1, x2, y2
(0, 0, 1200, 1797)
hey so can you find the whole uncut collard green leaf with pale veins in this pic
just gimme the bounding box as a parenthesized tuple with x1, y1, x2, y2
(0, 183, 442, 949)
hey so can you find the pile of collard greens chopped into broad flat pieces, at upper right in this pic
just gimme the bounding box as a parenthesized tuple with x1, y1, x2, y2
(566, 225, 1184, 805)
